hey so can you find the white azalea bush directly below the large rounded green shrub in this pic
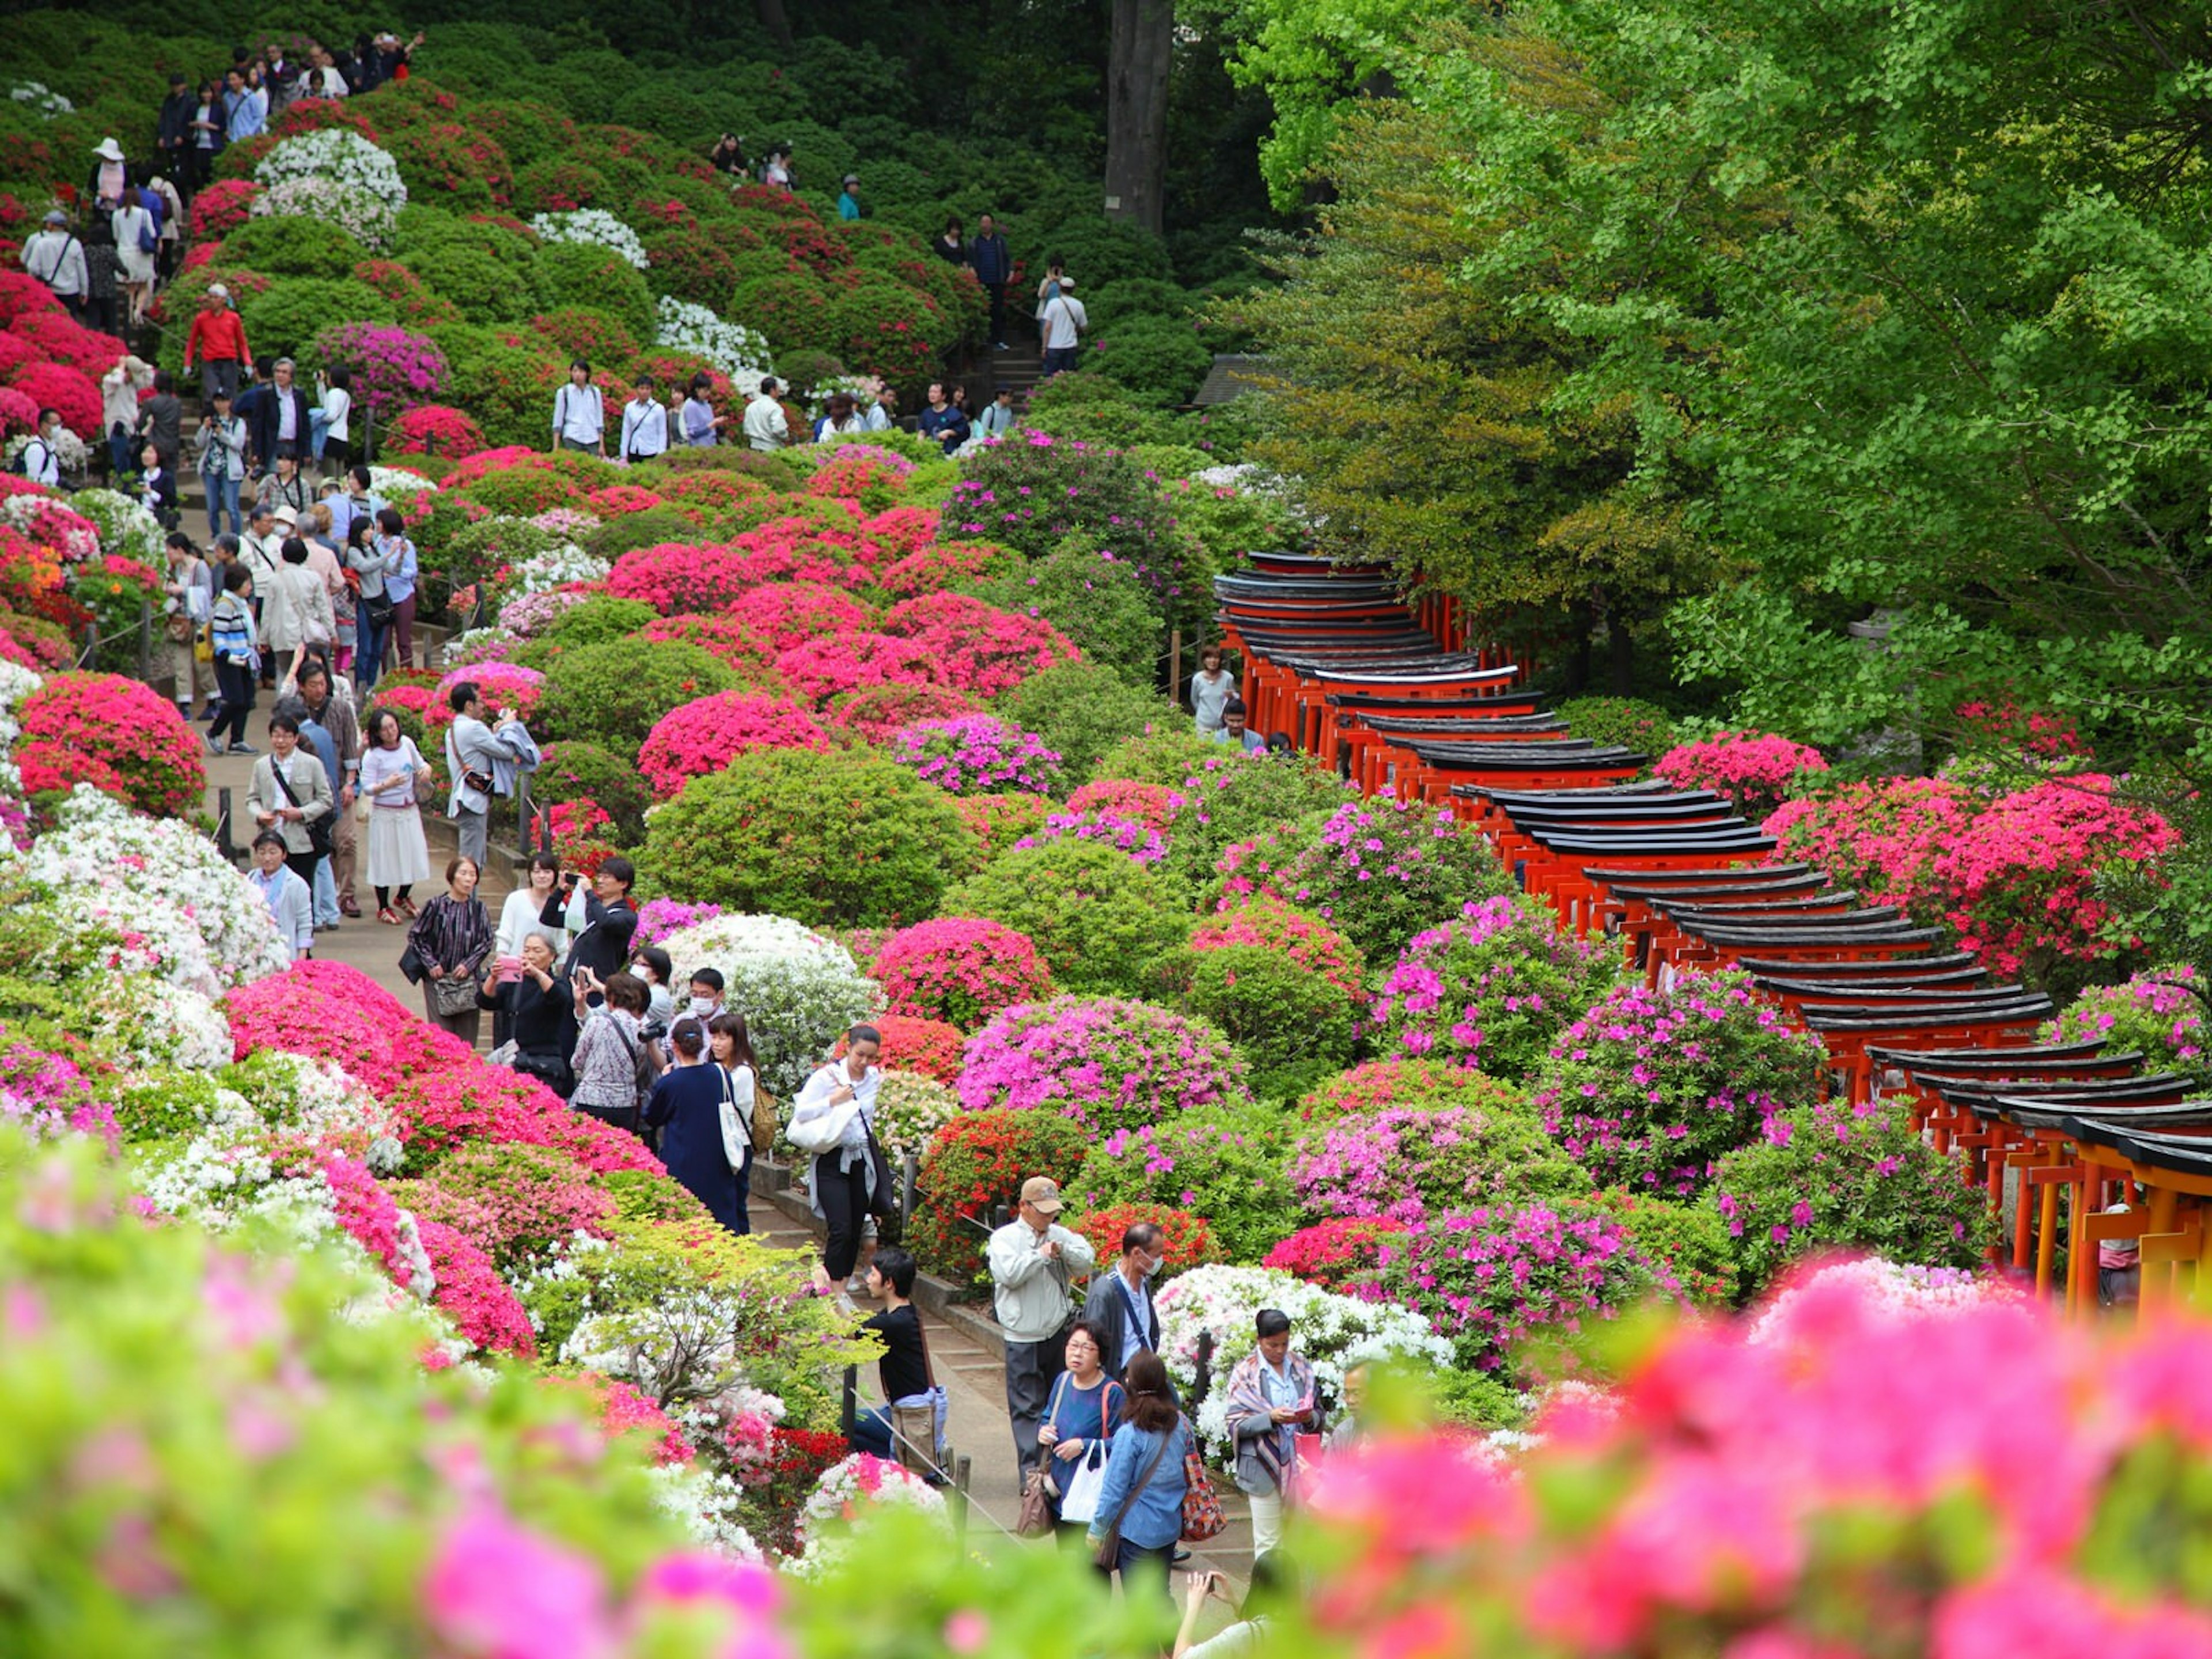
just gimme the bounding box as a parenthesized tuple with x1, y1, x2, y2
(659, 916, 882, 1101)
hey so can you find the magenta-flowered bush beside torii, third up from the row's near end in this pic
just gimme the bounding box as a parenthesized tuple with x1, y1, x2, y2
(1374, 898, 1619, 1077)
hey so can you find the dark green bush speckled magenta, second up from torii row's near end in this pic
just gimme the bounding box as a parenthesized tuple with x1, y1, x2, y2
(1531, 974, 1825, 1196)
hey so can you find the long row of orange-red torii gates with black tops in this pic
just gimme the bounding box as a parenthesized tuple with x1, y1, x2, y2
(1214, 553, 2212, 1319)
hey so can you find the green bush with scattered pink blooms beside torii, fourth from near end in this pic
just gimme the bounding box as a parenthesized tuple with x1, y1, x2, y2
(1214, 801, 1513, 962)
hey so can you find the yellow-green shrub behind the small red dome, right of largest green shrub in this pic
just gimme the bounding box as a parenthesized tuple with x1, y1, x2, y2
(942, 838, 1190, 995)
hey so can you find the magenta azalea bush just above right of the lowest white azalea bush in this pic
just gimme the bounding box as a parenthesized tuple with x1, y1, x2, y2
(1351, 1203, 1675, 1372)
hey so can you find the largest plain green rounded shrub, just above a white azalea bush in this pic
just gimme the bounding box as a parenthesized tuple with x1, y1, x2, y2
(628, 747, 973, 927)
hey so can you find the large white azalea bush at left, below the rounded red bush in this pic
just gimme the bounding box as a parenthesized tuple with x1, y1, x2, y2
(5, 783, 287, 998)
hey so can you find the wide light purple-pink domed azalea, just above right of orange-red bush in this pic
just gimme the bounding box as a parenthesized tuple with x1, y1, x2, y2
(960, 998, 1248, 1135)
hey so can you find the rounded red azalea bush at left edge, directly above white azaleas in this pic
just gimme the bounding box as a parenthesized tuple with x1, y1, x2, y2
(16, 672, 208, 819)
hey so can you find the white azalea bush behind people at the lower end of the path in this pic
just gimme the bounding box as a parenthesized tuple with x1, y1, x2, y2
(1157, 1267, 1451, 1469)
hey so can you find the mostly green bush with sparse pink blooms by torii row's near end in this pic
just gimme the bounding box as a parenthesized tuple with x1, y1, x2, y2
(1707, 1099, 1991, 1298)
